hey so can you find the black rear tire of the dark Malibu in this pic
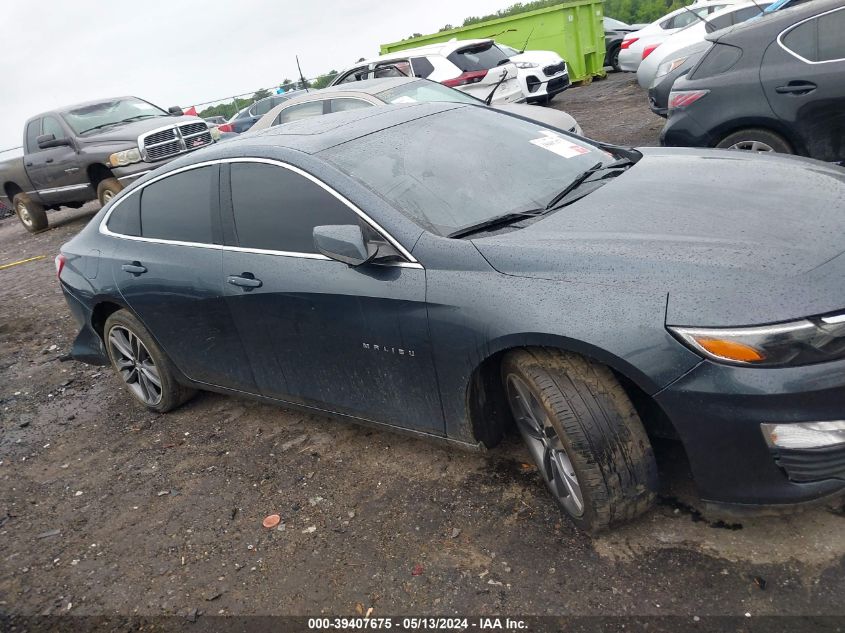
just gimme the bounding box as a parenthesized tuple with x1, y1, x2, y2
(103, 310, 196, 413)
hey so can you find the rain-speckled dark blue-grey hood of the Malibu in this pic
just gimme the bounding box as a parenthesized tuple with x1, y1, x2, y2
(473, 148, 845, 326)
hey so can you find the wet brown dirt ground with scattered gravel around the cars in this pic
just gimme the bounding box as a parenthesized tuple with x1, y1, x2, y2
(0, 75, 845, 630)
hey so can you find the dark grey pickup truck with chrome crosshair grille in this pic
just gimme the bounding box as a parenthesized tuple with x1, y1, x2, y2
(0, 97, 215, 233)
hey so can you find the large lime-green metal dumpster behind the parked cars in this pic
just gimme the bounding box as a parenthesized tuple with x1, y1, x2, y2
(381, 0, 604, 81)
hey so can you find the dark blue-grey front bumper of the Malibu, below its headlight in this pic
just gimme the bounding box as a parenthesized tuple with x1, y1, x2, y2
(655, 360, 845, 506)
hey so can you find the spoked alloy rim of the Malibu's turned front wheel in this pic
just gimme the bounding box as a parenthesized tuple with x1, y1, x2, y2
(507, 374, 584, 517)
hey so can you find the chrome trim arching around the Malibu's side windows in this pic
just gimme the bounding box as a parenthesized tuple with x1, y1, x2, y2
(98, 157, 423, 269)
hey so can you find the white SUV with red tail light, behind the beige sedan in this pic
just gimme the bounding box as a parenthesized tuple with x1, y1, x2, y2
(331, 39, 526, 105)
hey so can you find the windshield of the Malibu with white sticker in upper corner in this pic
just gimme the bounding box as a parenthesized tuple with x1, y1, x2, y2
(323, 106, 613, 236)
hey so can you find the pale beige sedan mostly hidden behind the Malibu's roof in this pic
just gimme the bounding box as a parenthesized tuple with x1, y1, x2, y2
(250, 77, 584, 136)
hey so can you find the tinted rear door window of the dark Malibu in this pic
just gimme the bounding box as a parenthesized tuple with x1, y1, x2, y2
(140, 165, 220, 244)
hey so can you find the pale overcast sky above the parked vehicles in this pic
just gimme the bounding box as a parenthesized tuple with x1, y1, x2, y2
(0, 0, 504, 151)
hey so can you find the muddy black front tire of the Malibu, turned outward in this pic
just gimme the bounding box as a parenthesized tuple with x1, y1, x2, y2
(502, 348, 657, 534)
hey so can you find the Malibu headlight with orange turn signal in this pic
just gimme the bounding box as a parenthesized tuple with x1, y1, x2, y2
(669, 313, 845, 367)
